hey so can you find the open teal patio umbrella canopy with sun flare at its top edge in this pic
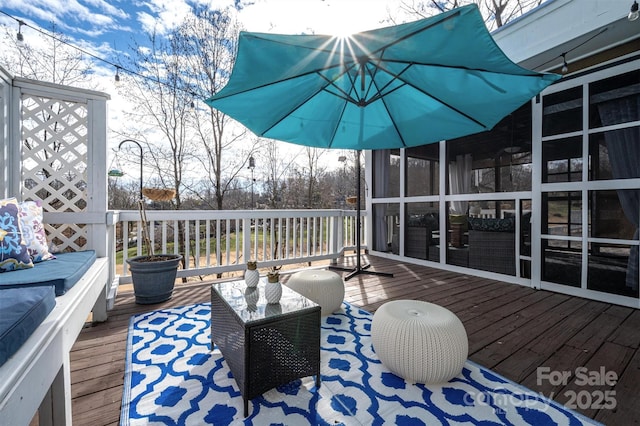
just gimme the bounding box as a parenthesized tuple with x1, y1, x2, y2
(206, 5, 560, 149)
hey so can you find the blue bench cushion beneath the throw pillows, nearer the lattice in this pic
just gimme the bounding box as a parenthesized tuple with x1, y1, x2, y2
(0, 250, 96, 296)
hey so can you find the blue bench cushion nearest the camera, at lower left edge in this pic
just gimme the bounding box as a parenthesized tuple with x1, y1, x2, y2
(0, 286, 56, 365)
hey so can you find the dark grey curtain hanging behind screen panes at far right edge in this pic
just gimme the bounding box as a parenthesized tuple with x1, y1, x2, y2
(598, 96, 640, 290)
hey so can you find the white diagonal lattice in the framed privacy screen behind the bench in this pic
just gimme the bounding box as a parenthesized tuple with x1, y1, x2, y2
(22, 95, 88, 251)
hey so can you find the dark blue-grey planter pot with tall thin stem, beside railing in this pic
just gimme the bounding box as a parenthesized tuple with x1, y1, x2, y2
(127, 188, 182, 304)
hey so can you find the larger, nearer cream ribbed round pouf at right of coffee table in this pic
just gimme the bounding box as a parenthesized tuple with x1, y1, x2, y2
(371, 300, 469, 383)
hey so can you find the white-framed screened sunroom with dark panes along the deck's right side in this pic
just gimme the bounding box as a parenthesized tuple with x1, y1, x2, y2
(367, 0, 640, 307)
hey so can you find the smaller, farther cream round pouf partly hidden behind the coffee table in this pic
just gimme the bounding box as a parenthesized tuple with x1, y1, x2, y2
(287, 269, 344, 316)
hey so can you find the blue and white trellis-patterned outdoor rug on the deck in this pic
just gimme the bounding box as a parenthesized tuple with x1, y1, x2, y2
(121, 303, 597, 426)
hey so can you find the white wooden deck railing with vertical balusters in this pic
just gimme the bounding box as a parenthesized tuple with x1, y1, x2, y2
(112, 210, 366, 284)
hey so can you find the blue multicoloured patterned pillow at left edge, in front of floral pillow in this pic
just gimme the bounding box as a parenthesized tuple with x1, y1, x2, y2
(0, 198, 33, 272)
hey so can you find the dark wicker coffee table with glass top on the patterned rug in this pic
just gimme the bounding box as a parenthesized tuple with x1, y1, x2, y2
(211, 278, 320, 417)
